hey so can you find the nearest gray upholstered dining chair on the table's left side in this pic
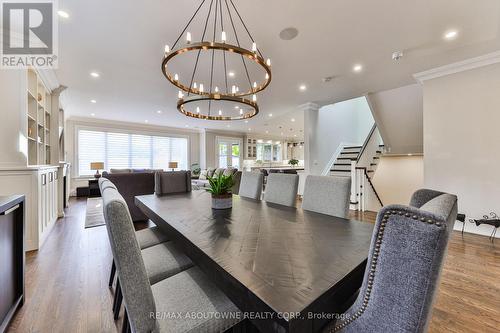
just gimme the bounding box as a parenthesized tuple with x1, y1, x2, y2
(103, 185, 241, 333)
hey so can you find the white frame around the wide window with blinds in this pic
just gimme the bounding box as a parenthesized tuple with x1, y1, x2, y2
(73, 124, 191, 179)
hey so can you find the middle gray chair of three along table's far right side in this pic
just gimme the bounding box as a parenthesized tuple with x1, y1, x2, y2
(264, 173, 299, 207)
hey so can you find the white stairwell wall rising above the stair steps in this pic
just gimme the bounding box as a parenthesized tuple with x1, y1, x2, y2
(304, 97, 374, 174)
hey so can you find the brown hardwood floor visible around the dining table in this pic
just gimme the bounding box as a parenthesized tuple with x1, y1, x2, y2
(8, 199, 500, 333)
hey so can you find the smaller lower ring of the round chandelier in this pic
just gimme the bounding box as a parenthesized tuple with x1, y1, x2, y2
(177, 94, 259, 120)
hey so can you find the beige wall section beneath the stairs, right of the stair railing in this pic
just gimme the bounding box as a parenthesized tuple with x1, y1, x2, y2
(372, 156, 424, 206)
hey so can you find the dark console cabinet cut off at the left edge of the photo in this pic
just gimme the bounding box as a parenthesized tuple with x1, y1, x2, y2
(0, 195, 25, 333)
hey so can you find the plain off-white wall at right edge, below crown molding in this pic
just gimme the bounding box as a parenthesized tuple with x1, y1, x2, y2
(424, 63, 500, 237)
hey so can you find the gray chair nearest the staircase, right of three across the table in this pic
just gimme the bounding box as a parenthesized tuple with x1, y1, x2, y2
(302, 176, 351, 218)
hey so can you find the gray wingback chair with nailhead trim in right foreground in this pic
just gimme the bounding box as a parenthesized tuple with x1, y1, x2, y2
(324, 189, 457, 333)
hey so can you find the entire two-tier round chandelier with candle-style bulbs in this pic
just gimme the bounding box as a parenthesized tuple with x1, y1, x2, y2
(161, 0, 272, 120)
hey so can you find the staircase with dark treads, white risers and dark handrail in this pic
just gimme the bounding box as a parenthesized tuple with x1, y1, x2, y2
(329, 125, 384, 211)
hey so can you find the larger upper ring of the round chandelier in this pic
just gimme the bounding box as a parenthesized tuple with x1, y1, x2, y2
(161, 42, 272, 97)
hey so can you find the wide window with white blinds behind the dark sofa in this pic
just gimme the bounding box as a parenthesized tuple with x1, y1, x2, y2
(78, 129, 188, 176)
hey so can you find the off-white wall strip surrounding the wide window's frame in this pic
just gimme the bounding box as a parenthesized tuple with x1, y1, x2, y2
(65, 118, 200, 195)
